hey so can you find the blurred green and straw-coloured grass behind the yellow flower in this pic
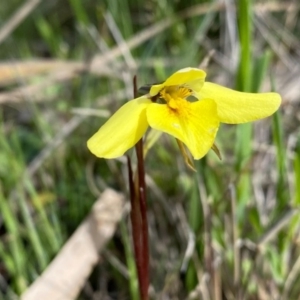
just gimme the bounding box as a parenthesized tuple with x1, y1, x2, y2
(0, 0, 300, 299)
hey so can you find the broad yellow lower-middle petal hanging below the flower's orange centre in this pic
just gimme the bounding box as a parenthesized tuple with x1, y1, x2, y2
(147, 99, 219, 159)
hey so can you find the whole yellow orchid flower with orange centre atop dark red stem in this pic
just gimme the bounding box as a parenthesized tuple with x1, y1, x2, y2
(87, 68, 281, 159)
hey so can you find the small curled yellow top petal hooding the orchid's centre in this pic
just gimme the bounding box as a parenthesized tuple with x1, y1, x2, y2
(150, 68, 206, 97)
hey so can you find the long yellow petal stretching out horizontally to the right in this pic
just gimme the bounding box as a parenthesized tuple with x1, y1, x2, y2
(199, 82, 281, 124)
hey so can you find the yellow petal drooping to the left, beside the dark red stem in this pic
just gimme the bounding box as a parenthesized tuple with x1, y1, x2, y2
(87, 96, 152, 158)
